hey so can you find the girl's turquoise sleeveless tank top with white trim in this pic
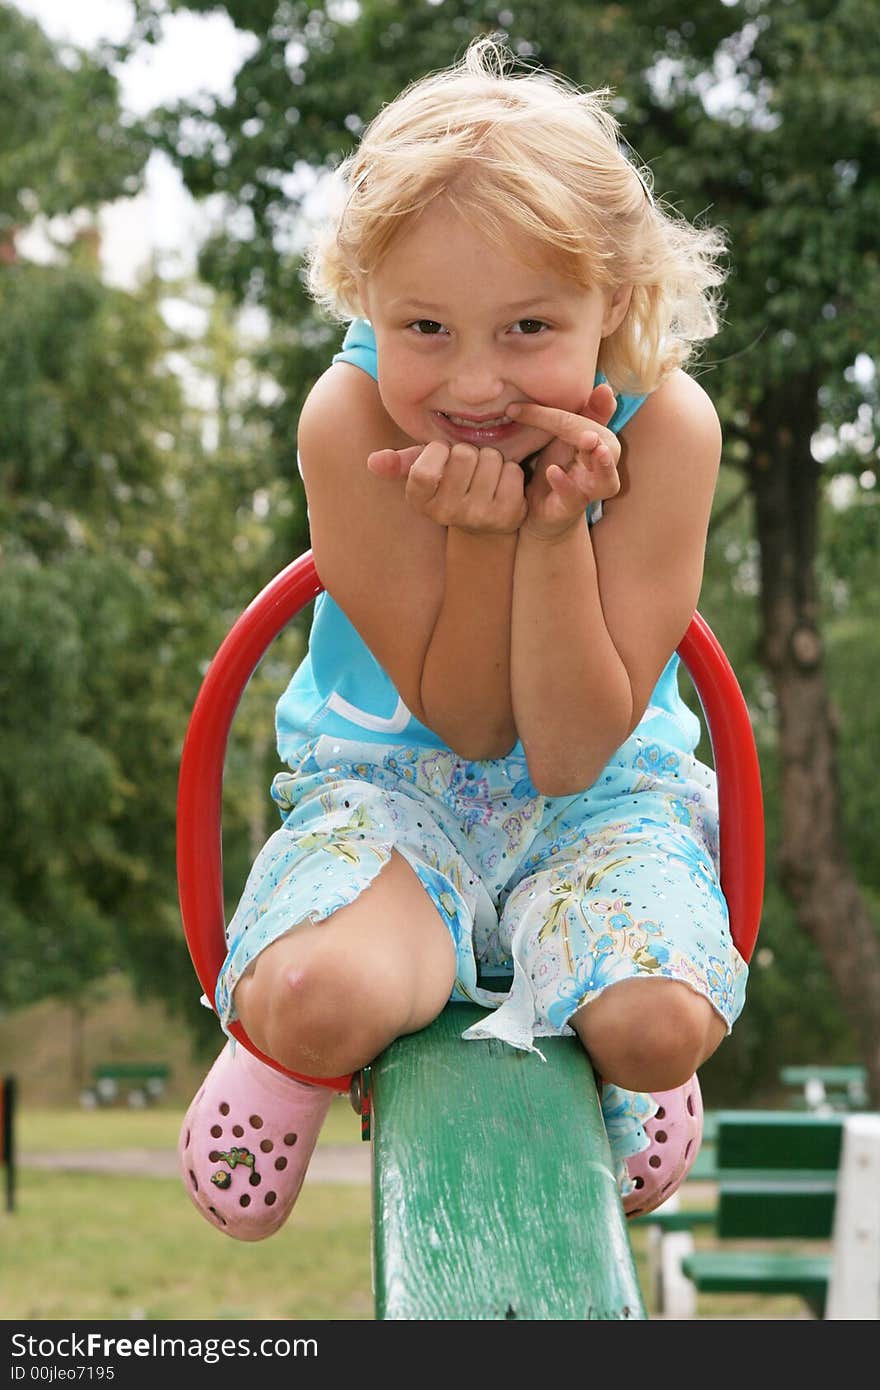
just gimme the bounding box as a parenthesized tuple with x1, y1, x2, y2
(275, 318, 701, 763)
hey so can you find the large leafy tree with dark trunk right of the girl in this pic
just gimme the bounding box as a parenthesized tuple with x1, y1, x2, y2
(139, 0, 880, 1099)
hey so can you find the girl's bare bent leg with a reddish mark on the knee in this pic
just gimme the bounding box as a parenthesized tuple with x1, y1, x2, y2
(229, 853, 455, 1076)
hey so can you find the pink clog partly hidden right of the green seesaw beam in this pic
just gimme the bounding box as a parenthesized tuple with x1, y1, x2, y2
(623, 1076, 703, 1216)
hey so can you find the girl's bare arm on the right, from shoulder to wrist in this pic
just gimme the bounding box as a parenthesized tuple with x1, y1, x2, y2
(510, 373, 720, 795)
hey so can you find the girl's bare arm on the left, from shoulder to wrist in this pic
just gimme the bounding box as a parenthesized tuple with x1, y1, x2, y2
(299, 364, 524, 759)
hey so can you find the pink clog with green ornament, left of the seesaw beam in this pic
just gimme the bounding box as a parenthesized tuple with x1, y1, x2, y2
(178, 1043, 334, 1240)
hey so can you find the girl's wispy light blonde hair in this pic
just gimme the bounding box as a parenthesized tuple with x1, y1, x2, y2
(307, 38, 724, 392)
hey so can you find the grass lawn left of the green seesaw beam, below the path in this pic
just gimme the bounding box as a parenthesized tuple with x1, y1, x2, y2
(0, 1169, 373, 1321)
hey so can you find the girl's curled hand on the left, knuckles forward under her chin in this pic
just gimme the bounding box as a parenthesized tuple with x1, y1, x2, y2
(367, 439, 527, 535)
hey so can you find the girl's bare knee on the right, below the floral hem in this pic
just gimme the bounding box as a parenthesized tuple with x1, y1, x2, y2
(571, 980, 727, 1091)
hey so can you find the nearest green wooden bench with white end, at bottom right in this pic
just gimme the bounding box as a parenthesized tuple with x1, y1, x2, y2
(681, 1111, 880, 1319)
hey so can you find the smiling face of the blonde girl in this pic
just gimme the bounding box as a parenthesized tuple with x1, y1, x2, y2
(361, 199, 630, 463)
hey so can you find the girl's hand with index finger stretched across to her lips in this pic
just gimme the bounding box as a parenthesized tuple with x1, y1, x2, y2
(507, 385, 620, 539)
